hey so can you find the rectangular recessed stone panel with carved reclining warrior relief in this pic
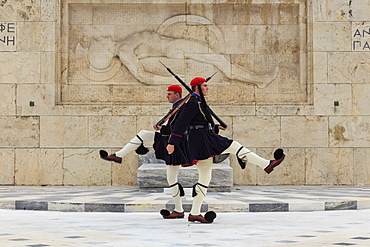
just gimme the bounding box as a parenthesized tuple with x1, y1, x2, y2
(60, 0, 310, 103)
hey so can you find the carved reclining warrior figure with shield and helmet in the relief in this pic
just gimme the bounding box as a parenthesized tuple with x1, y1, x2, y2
(72, 15, 278, 88)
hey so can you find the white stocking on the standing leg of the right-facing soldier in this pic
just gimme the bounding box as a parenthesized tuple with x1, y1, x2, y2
(190, 158, 213, 215)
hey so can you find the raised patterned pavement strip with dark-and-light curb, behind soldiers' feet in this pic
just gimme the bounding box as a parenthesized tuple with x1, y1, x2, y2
(0, 186, 370, 212)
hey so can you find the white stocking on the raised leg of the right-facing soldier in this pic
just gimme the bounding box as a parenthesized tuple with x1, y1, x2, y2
(222, 141, 270, 169)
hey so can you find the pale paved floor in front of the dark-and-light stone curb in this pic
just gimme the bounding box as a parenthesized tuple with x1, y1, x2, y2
(0, 209, 370, 247)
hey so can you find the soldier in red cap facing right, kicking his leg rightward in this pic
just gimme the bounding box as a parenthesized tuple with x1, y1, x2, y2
(167, 77, 285, 223)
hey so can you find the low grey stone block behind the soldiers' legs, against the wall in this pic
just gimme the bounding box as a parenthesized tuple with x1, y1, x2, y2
(138, 160, 233, 192)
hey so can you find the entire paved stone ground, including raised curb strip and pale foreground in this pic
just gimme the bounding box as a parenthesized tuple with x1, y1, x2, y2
(0, 186, 370, 247)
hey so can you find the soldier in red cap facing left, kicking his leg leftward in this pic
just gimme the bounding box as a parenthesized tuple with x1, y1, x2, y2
(100, 85, 190, 219)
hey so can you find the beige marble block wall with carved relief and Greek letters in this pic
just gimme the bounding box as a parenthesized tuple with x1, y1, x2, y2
(0, 0, 370, 186)
